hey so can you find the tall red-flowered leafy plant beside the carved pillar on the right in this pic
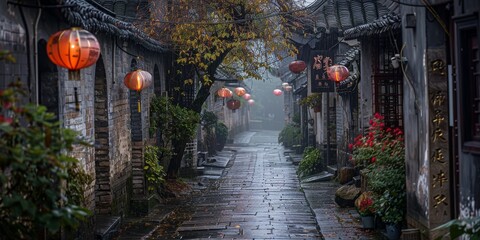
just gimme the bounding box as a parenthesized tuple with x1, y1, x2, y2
(350, 113, 406, 239)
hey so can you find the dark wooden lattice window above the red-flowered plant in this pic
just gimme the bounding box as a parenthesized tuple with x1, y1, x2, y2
(372, 35, 403, 128)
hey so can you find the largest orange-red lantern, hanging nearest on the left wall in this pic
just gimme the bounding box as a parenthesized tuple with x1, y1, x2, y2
(47, 27, 100, 80)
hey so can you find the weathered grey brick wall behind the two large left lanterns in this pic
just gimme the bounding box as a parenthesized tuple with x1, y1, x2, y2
(0, 1, 165, 218)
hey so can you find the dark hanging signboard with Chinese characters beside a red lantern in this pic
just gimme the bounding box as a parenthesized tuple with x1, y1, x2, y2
(310, 51, 335, 92)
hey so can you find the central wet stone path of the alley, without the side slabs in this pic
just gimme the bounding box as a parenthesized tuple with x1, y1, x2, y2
(150, 131, 321, 239)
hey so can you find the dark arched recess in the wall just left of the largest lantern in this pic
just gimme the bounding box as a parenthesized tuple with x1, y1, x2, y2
(37, 39, 59, 120)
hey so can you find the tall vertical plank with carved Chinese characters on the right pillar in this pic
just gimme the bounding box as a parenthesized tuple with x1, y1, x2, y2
(427, 49, 452, 227)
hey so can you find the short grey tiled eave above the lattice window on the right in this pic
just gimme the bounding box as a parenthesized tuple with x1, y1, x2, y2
(343, 14, 402, 39)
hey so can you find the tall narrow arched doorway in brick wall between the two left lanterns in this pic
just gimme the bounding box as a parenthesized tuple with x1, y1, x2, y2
(94, 56, 112, 214)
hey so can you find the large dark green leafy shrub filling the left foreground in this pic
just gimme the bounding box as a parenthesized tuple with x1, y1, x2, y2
(0, 82, 92, 236)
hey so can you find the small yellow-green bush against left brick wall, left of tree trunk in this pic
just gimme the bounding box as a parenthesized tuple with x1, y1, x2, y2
(143, 146, 165, 193)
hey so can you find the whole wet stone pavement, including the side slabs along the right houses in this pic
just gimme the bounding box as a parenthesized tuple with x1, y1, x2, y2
(117, 131, 381, 239)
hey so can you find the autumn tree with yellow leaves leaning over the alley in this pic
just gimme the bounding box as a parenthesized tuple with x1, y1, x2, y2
(142, 0, 302, 176)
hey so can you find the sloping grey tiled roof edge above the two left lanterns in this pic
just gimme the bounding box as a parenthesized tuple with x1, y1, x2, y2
(62, 0, 165, 52)
